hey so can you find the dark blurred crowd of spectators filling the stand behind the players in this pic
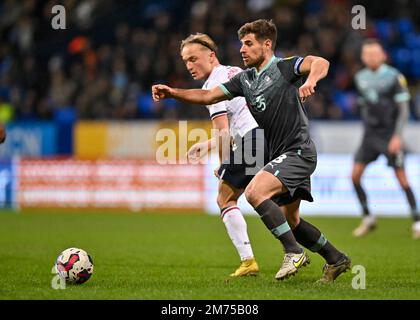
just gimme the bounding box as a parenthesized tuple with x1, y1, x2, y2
(0, 0, 420, 121)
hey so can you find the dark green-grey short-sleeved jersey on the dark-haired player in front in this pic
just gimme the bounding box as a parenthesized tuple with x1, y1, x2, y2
(220, 56, 315, 160)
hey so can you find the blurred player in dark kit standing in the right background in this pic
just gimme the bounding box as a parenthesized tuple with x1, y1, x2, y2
(352, 39, 420, 239)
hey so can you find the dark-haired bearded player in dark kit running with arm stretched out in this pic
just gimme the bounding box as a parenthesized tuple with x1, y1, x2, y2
(152, 19, 351, 282)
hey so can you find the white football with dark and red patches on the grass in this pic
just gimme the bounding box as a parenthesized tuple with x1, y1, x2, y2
(55, 248, 93, 284)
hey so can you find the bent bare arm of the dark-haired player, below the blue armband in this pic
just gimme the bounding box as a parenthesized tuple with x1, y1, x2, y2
(299, 56, 330, 101)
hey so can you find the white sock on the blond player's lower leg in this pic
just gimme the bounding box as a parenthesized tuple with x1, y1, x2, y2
(221, 206, 254, 261)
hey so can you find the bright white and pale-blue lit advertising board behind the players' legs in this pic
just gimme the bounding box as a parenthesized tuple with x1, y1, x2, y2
(206, 154, 420, 216)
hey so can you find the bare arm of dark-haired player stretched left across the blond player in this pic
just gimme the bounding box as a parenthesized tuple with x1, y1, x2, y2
(152, 84, 228, 105)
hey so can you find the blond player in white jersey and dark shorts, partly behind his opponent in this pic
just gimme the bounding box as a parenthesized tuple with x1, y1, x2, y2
(180, 33, 267, 277)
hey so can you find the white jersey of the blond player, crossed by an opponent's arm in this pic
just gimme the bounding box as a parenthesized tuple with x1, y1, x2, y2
(203, 65, 258, 137)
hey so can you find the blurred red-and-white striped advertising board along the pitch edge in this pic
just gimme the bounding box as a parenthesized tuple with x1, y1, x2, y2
(17, 159, 204, 210)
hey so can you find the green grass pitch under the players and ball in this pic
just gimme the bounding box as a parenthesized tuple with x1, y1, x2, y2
(0, 211, 420, 300)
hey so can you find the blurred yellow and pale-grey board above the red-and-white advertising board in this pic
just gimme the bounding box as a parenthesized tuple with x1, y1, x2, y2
(74, 121, 211, 159)
